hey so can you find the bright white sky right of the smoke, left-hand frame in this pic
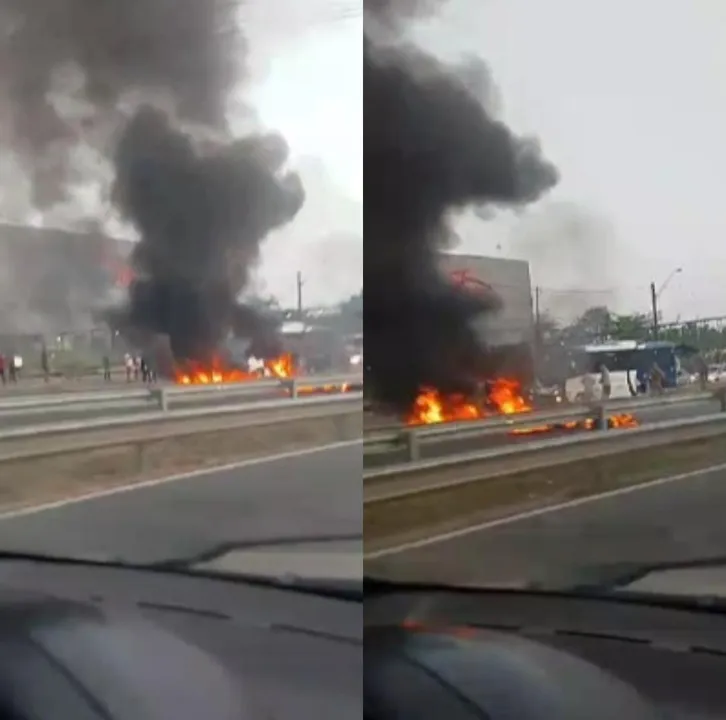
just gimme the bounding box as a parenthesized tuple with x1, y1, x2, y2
(240, 0, 363, 306)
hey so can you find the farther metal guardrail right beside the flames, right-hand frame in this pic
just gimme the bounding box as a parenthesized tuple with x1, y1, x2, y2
(364, 393, 726, 462)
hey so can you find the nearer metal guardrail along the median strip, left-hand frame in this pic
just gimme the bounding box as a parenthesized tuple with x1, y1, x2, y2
(0, 392, 363, 443)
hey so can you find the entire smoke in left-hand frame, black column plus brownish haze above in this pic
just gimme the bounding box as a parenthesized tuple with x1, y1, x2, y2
(0, 0, 303, 360)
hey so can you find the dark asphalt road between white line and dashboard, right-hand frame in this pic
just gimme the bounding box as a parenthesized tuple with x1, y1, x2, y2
(366, 467, 726, 585)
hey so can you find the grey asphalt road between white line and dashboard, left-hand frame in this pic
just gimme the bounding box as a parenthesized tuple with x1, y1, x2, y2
(0, 443, 363, 562)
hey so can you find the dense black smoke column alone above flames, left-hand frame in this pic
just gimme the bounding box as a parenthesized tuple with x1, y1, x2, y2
(114, 107, 304, 361)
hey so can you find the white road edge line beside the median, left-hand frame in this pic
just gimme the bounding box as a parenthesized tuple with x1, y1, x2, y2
(0, 440, 363, 522)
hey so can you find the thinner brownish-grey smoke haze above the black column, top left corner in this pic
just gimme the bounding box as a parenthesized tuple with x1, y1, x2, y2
(0, 0, 245, 208)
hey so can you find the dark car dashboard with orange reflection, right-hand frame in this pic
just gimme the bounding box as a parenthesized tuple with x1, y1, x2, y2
(364, 582, 726, 720)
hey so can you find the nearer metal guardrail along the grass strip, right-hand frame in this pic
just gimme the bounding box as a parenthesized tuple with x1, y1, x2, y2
(363, 412, 726, 503)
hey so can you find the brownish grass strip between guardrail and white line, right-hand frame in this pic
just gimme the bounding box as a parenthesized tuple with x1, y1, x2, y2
(363, 435, 726, 552)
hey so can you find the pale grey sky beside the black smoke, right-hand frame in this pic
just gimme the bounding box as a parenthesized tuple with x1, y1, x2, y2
(406, 0, 726, 321)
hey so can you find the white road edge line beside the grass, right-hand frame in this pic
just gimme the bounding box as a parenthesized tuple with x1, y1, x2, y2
(370, 463, 726, 560)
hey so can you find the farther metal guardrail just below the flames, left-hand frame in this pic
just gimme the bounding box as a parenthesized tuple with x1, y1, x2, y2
(0, 375, 362, 419)
